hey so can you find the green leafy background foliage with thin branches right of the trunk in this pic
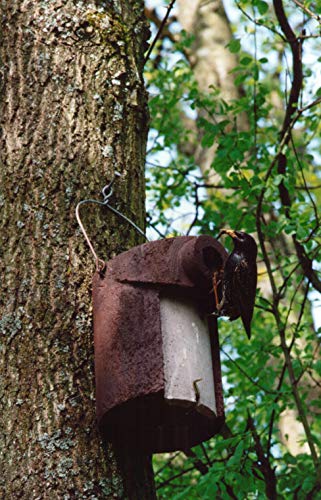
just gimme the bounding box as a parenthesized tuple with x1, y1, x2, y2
(146, 0, 321, 500)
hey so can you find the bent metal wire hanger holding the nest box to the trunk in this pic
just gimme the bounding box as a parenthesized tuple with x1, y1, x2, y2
(76, 172, 148, 273)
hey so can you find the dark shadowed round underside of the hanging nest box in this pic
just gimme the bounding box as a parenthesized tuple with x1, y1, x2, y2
(98, 391, 225, 453)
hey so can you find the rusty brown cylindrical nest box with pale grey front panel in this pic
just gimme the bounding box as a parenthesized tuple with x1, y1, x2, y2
(93, 236, 227, 453)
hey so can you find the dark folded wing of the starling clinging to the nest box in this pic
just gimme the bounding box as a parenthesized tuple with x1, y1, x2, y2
(233, 259, 257, 338)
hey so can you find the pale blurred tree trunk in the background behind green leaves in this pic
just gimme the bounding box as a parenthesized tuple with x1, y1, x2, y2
(177, 0, 249, 174)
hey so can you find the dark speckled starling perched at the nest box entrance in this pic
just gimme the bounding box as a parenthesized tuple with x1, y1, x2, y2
(213, 229, 257, 339)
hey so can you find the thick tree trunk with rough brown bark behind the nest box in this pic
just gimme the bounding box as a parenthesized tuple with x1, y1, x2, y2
(0, 0, 154, 500)
